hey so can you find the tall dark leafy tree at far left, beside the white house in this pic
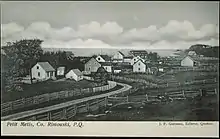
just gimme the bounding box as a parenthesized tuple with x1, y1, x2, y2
(2, 39, 43, 88)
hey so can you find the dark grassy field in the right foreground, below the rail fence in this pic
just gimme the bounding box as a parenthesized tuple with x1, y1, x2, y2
(71, 96, 218, 121)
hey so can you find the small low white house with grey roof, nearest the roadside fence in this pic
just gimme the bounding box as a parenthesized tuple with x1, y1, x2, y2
(65, 69, 83, 81)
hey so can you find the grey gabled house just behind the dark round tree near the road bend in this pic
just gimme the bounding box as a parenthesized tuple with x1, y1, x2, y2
(84, 57, 102, 73)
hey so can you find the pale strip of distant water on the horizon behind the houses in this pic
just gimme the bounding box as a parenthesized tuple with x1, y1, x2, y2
(43, 48, 184, 57)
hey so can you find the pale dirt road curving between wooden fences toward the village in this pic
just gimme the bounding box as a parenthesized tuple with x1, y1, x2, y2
(1, 83, 132, 121)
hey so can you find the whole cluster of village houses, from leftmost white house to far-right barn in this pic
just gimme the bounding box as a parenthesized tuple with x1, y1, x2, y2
(31, 50, 218, 81)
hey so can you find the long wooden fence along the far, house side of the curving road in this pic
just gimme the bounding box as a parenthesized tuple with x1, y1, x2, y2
(1, 81, 116, 113)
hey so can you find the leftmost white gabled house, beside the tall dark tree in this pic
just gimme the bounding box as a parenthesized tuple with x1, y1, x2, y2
(31, 62, 56, 81)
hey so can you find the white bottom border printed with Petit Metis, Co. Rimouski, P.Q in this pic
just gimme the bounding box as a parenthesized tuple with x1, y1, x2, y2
(1, 121, 219, 137)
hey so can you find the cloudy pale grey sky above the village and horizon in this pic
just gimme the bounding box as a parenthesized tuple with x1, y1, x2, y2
(1, 1, 219, 49)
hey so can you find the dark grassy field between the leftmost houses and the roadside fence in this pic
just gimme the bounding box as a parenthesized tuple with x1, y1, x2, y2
(1, 80, 96, 103)
